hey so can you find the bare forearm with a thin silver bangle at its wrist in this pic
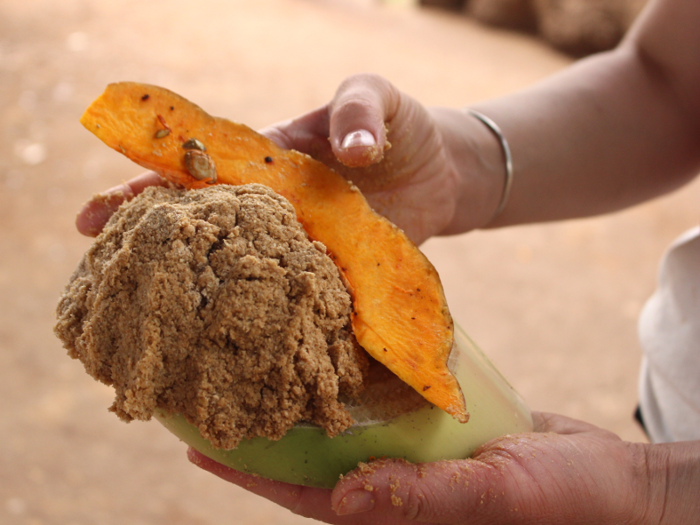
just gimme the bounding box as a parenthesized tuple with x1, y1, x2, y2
(438, 0, 700, 233)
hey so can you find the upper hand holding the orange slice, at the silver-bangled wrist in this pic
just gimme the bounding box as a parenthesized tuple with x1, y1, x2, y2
(77, 75, 502, 244)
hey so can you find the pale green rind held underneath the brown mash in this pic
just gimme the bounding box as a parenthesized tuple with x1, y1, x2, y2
(156, 327, 532, 488)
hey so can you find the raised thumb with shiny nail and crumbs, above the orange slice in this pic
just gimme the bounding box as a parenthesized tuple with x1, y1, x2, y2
(329, 74, 401, 168)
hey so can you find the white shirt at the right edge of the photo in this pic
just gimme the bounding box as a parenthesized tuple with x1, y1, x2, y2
(639, 227, 700, 443)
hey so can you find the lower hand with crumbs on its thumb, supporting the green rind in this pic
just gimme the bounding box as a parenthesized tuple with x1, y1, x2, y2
(188, 413, 663, 525)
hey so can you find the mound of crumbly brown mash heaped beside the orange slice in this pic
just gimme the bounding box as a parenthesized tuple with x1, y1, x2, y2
(56, 185, 368, 449)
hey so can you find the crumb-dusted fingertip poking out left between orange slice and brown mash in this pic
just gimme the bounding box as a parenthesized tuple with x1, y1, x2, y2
(75, 171, 166, 237)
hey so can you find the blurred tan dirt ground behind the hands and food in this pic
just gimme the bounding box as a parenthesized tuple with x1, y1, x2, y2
(0, 0, 700, 525)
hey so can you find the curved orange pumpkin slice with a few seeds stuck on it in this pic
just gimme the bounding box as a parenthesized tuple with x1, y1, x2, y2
(81, 82, 468, 422)
